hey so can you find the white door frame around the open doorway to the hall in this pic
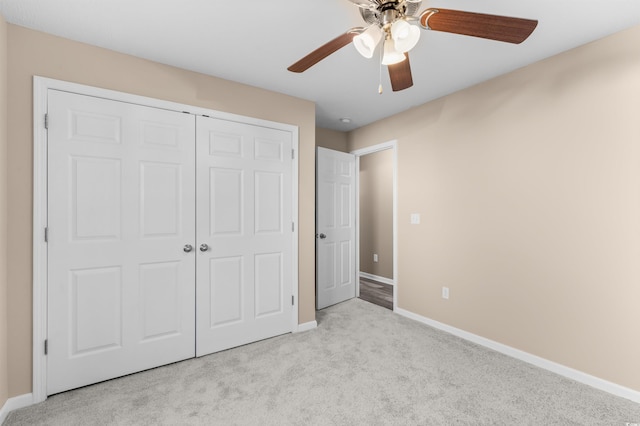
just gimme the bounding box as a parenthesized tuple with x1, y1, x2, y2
(351, 140, 398, 311)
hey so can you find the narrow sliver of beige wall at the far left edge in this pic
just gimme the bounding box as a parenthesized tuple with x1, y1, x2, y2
(0, 10, 9, 409)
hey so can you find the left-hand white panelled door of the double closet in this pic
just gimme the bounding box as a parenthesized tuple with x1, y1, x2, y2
(47, 90, 196, 394)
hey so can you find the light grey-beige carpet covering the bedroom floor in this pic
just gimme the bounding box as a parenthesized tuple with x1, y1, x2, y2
(5, 299, 640, 426)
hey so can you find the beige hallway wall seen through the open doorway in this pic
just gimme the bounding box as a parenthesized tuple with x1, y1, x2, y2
(359, 149, 393, 279)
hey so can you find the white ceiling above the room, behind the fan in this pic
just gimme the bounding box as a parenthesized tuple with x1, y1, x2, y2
(0, 0, 640, 131)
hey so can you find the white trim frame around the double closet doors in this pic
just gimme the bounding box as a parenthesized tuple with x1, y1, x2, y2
(32, 76, 299, 404)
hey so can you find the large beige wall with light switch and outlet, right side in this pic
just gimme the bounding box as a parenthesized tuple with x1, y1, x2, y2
(349, 27, 640, 391)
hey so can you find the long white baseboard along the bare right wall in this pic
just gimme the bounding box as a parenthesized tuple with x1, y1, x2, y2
(395, 308, 640, 403)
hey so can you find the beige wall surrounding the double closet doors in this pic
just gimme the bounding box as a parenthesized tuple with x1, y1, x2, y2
(8, 25, 315, 396)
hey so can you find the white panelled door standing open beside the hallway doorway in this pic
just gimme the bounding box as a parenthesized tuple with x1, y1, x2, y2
(316, 148, 356, 309)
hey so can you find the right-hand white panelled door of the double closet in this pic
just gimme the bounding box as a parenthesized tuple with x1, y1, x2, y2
(196, 117, 293, 356)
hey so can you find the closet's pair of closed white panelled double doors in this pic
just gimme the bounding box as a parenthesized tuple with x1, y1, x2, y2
(46, 89, 297, 394)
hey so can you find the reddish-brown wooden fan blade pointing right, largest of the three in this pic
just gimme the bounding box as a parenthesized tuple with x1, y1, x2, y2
(420, 9, 538, 44)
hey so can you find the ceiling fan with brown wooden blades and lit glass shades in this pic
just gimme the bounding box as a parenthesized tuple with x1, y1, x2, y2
(287, 0, 538, 93)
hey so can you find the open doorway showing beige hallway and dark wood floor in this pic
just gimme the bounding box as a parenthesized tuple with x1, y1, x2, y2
(352, 141, 397, 310)
